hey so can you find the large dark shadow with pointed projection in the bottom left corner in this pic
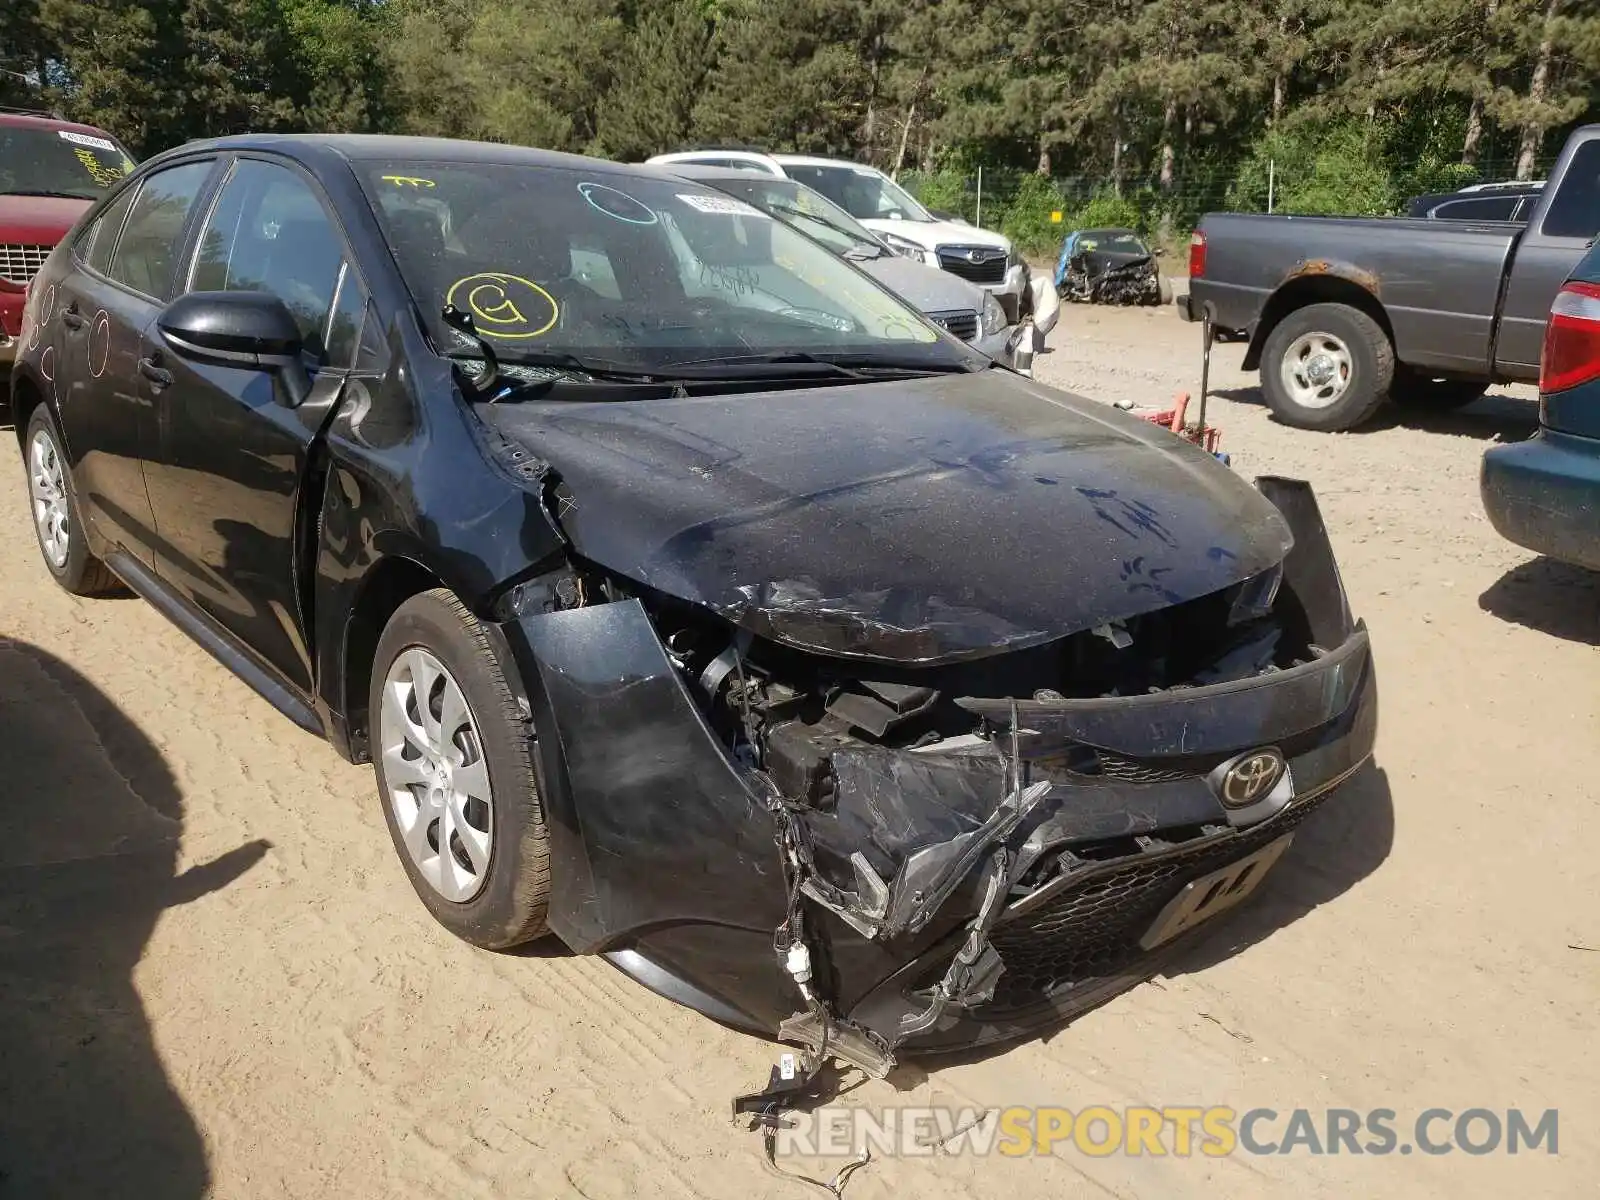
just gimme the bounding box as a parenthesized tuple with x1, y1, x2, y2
(0, 637, 269, 1200)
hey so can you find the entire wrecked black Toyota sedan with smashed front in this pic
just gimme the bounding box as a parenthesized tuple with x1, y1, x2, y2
(14, 138, 1376, 1072)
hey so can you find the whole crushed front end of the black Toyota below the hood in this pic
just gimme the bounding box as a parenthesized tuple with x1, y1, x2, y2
(501, 478, 1376, 1074)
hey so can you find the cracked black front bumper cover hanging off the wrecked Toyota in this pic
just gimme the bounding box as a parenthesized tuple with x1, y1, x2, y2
(499, 478, 1378, 1064)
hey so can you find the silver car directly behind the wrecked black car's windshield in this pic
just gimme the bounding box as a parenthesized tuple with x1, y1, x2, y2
(666, 163, 1054, 373)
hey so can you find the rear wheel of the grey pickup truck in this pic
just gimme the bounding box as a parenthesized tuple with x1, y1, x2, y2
(1261, 304, 1395, 432)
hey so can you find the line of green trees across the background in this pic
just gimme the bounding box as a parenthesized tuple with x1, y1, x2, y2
(9, 0, 1600, 244)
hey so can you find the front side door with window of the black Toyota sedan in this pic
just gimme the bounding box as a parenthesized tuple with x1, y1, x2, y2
(146, 157, 368, 693)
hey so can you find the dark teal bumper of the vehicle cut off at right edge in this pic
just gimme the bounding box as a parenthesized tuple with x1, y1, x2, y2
(1478, 429, 1600, 570)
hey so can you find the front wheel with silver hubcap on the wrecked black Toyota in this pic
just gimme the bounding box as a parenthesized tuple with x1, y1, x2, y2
(368, 589, 550, 950)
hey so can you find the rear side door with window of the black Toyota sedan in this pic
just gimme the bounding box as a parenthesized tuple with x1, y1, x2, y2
(50, 158, 216, 565)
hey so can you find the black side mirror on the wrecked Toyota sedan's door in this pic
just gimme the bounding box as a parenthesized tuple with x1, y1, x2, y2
(155, 291, 310, 408)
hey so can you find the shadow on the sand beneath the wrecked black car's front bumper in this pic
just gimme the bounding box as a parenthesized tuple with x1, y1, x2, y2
(890, 762, 1395, 1091)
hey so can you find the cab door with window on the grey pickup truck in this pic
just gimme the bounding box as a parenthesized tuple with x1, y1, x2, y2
(1494, 138, 1600, 371)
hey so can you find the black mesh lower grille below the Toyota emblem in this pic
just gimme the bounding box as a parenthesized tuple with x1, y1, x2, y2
(982, 790, 1333, 1013)
